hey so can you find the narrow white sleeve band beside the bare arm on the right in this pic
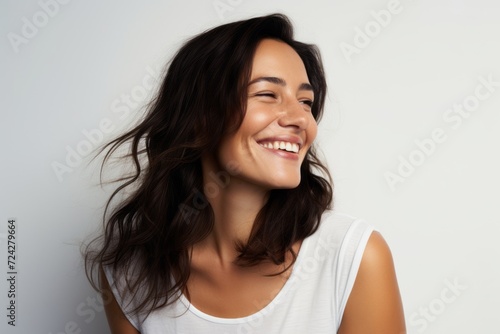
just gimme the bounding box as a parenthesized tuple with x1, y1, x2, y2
(335, 219, 374, 320)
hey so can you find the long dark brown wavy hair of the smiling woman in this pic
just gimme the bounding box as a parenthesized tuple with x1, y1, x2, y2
(84, 14, 332, 314)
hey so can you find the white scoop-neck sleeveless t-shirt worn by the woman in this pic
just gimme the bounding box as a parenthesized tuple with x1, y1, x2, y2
(105, 211, 373, 334)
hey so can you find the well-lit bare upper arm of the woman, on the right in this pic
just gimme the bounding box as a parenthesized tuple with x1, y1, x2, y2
(338, 232, 406, 334)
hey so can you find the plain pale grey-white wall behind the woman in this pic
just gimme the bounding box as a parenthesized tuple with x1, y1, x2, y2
(0, 0, 500, 334)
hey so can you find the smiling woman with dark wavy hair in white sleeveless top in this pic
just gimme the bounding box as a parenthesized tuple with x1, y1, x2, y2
(87, 15, 405, 334)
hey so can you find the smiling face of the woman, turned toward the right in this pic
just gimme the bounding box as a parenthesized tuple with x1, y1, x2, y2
(218, 39, 317, 189)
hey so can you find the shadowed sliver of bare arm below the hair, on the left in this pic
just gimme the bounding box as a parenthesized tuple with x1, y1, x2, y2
(100, 269, 140, 334)
